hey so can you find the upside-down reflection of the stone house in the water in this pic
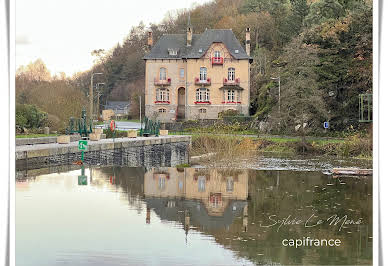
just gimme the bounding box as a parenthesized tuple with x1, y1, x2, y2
(144, 168, 248, 232)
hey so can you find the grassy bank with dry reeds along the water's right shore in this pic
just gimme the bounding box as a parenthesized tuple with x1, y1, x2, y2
(192, 134, 373, 159)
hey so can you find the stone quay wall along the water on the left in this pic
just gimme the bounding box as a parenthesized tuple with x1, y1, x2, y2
(15, 136, 191, 169)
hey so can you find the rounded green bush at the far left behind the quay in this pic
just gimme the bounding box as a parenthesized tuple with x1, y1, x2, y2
(15, 104, 47, 129)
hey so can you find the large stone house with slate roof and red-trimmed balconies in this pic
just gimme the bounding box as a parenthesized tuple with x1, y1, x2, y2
(144, 25, 252, 122)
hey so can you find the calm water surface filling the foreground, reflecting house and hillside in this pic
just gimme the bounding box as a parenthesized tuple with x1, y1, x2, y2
(16, 167, 372, 266)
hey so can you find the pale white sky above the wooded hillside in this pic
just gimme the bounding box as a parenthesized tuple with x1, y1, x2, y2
(15, 0, 210, 76)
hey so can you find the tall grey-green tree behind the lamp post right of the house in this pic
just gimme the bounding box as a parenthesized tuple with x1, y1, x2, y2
(270, 36, 328, 143)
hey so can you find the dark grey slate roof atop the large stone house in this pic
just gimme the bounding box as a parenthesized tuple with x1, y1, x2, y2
(144, 29, 252, 60)
